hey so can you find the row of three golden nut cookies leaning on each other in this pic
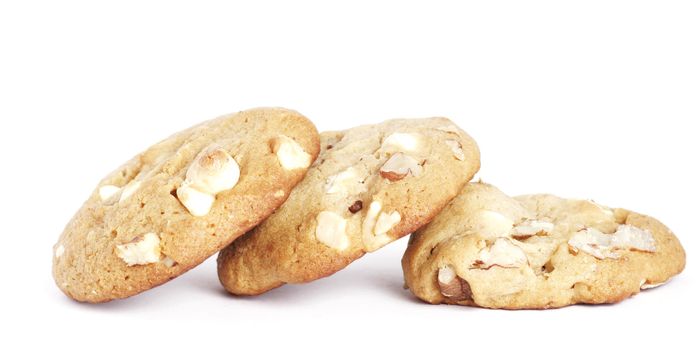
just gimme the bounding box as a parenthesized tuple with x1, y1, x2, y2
(53, 108, 685, 309)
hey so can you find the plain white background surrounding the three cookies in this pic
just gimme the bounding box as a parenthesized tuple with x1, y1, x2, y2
(0, 0, 698, 349)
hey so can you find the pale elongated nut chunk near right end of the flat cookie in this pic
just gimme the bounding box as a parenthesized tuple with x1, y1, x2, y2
(567, 225, 656, 259)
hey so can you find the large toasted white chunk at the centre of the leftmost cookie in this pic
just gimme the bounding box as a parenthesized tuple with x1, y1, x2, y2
(177, 145, 240, 216)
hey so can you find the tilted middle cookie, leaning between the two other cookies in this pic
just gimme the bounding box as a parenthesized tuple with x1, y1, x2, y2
(218, 118, 480, 295)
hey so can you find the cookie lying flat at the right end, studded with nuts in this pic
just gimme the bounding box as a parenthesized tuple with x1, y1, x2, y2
(402, 183, 686, 309)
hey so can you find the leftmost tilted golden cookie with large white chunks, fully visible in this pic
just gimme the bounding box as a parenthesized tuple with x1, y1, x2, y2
(53, 108, 320, 303)
